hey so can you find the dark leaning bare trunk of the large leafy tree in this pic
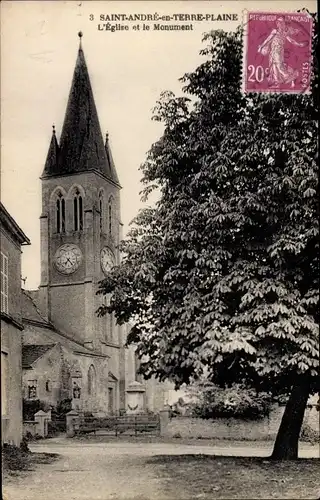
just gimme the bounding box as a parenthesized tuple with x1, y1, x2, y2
(271, 376, 310, 460)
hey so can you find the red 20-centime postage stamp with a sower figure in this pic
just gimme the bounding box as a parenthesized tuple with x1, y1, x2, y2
(242, 12, 313, 93)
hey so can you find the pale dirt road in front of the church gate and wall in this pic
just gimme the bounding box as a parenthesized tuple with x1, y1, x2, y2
(4, 438, 317, 500)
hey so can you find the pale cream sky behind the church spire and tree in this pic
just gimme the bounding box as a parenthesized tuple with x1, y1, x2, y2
(0, 0, 316, 288)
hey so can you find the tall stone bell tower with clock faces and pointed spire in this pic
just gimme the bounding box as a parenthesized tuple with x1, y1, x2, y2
(40, 32, 121, 353)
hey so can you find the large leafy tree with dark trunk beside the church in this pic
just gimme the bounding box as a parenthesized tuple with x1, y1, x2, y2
(99, 14, 319, 458)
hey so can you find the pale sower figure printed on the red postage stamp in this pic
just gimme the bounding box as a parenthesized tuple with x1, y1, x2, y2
(258, 17, 306, 87)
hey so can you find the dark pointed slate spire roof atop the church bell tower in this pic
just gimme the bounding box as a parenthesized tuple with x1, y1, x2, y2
(42, 36, 120, 187)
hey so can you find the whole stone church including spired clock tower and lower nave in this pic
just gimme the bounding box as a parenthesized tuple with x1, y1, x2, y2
(22, 33, 175, 414)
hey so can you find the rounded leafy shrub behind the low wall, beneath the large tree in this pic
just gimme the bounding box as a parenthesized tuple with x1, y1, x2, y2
(190, 384, 272, 420)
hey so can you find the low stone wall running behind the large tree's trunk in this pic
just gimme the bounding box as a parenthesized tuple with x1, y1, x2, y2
(166, 406, 319, 441)
